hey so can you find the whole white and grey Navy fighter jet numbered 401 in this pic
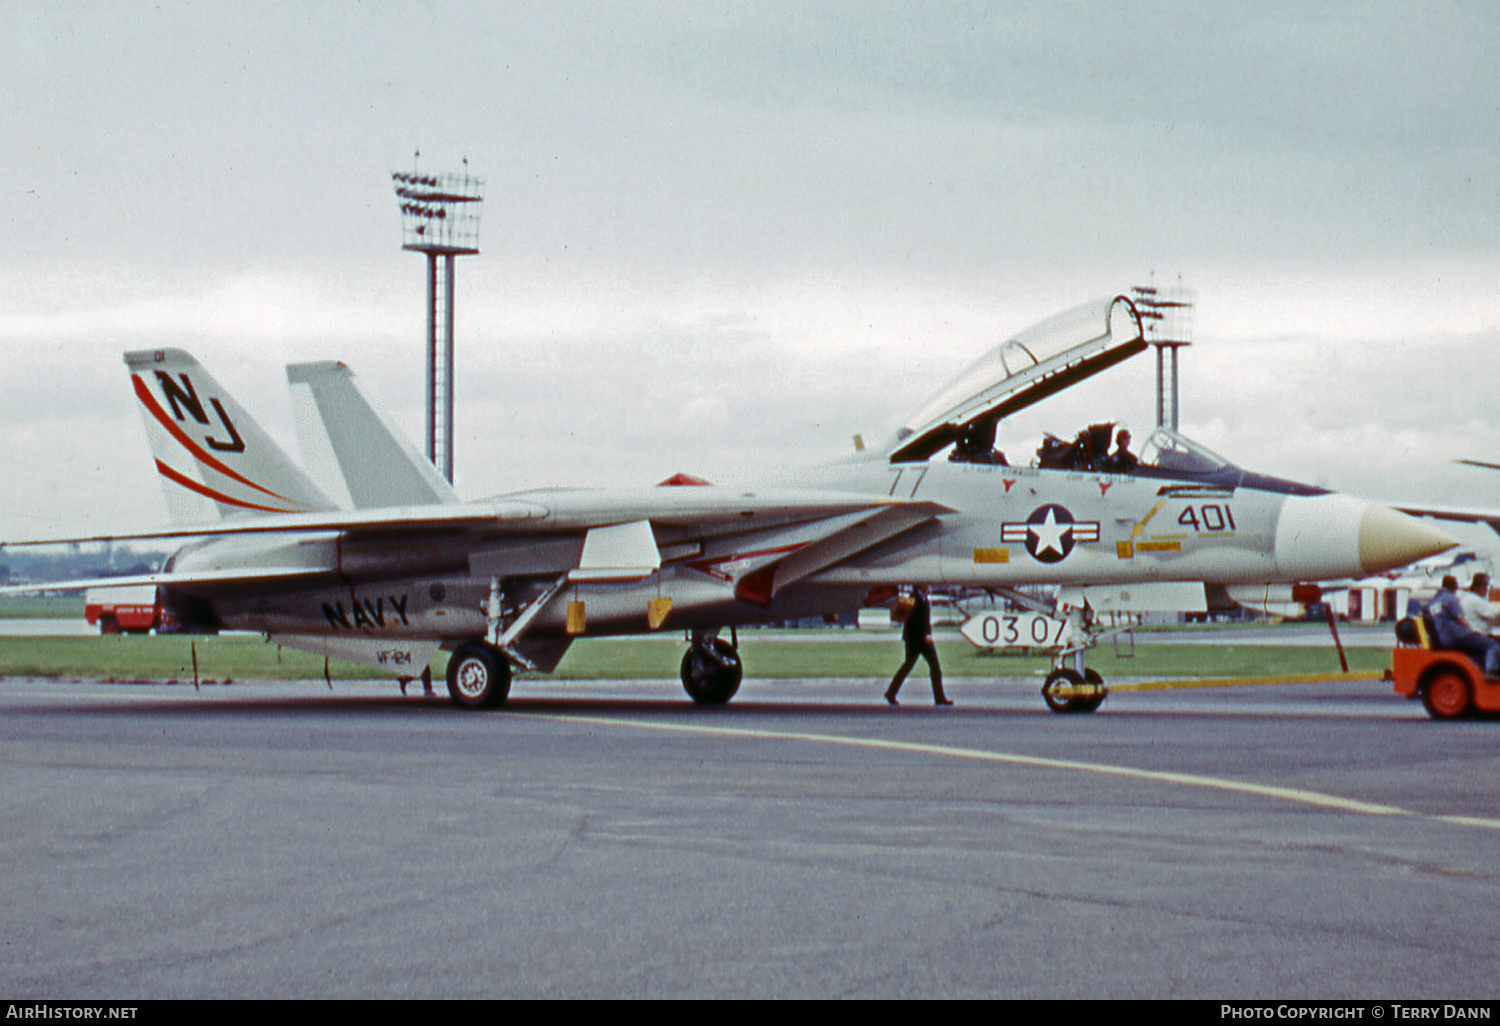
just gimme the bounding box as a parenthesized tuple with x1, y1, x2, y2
(3, 296, 1452, 711)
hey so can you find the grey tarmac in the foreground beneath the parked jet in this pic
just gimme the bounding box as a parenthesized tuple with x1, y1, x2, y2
(0, 678, 1500, 1001)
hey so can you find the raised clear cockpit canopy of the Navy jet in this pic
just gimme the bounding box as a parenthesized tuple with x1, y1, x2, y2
(888, 296, 1146, 462)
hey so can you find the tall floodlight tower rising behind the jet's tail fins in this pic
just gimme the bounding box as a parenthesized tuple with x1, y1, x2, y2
(390, 152, 485, 483)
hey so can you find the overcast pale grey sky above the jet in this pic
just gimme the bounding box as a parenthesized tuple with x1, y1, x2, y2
(0, 0, 1500, 539)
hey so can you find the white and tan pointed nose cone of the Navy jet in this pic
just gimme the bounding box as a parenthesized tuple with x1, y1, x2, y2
(1275, 494, 1457, 581)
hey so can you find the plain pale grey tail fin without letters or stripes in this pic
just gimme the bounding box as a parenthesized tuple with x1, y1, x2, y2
(287, 360, 459, 510)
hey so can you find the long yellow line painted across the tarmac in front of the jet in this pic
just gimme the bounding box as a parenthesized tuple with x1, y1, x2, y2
(509, 713, 1416, 816)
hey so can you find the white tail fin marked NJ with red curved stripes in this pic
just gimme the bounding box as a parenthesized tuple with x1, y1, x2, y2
(125, 350, 336, 527)
